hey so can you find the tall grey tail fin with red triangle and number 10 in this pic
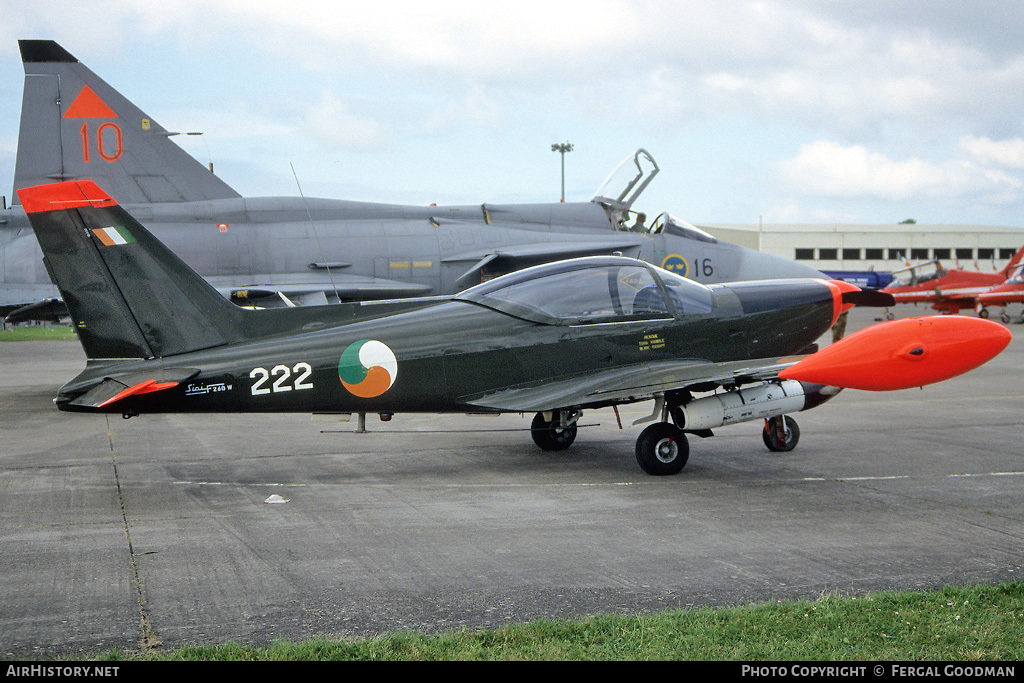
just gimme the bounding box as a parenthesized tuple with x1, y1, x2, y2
(14, 40, 240, 205)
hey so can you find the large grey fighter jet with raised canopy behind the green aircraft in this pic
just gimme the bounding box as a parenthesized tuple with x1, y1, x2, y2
(0, 40, 822, 322)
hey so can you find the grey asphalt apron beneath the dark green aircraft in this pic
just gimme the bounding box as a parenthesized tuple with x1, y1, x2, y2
(0, 307, 1024, 658)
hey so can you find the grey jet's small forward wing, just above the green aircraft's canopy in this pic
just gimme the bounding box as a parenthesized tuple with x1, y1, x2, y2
(441, 239, 640, 287)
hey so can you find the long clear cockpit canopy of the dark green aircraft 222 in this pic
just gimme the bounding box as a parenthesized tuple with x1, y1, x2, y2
(456, 256, 712, 325)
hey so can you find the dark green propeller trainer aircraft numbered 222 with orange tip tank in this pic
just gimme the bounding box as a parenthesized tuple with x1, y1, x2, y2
(18, 180, 1010, 474)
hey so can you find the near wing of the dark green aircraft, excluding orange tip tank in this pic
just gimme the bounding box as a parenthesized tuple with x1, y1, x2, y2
(463, 355, 806, 413)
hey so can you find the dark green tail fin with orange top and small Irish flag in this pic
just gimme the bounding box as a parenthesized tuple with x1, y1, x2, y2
(17, 180, 246, 358)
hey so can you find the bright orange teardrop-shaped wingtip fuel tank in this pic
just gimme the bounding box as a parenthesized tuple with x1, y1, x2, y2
(779, 315, 1012, 391)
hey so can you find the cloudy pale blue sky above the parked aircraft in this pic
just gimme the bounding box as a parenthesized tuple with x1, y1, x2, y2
(0, 0, 1024, 226)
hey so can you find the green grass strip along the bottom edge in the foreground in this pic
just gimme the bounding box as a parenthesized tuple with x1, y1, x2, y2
(90, 584, 1024, 661)
